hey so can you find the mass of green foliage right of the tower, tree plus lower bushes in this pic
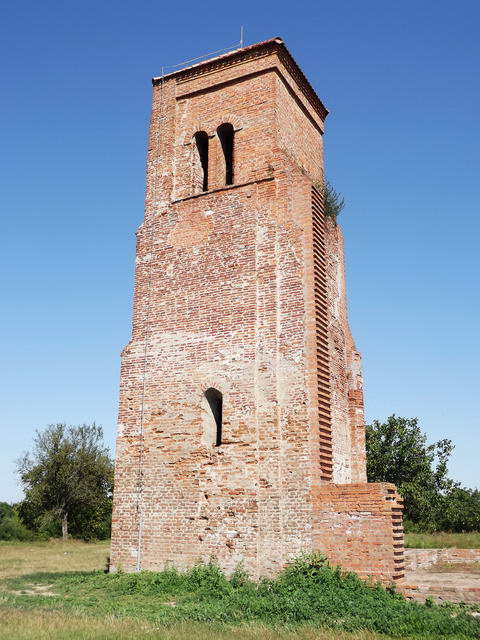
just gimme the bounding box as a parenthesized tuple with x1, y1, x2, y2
(366, 415, 480, 531)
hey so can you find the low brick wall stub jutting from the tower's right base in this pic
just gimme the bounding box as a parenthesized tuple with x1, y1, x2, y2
(313, 483, 404, 583)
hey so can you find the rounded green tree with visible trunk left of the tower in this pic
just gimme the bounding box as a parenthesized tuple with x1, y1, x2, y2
(17, 423, 113, 539)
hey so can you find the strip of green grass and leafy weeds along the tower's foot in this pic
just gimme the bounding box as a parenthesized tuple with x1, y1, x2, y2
(3, 556, 480, 638)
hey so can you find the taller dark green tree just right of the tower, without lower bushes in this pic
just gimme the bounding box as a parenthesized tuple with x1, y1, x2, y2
(366, 415, 458, 529)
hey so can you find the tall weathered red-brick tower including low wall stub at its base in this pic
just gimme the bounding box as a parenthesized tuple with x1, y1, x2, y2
(111, 38, 403, 580)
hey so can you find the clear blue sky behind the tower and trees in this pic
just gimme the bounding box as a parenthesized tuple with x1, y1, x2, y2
(0, 0, 480, 500)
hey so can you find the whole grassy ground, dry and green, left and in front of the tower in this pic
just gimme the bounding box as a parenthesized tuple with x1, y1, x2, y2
(0, 541, 480, 640)
